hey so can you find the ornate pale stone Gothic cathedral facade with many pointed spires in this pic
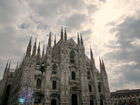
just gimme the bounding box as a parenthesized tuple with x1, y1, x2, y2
(0, 29, 111, 105)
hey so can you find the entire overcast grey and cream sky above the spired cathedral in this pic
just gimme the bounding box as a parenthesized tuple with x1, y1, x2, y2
(0, 0, 140, 91)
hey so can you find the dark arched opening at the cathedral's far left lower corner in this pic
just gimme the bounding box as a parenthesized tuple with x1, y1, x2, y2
(2, 85, 11, 105)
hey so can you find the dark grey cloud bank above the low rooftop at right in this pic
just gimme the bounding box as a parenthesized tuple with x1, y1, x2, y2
(105, 17, 140, 91)
